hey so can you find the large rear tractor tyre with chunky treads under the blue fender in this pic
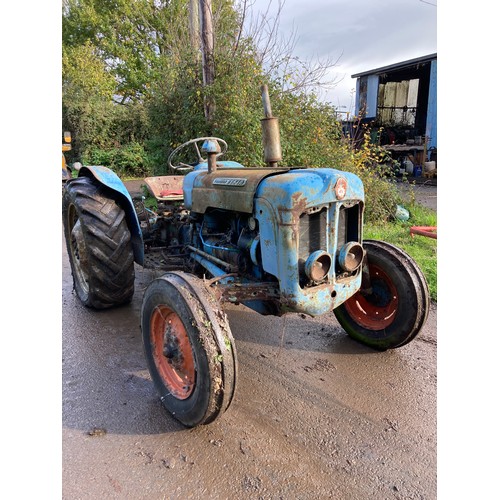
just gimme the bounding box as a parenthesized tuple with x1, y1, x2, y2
(62, 177, 135, 309)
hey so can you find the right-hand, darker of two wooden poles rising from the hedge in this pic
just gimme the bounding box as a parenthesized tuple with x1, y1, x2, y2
(199, 0, 215, 124)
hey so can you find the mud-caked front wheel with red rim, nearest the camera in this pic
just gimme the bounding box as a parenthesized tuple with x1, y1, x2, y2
(141, 272, 237, 427)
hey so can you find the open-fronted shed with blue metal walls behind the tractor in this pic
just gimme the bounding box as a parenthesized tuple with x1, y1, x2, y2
(352, 54, 437, 155)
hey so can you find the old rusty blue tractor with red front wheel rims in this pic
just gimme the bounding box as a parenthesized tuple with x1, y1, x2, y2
(63, 88, 429, 427)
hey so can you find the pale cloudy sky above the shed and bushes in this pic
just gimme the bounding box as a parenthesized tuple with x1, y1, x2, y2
(244, 0, 437, 113)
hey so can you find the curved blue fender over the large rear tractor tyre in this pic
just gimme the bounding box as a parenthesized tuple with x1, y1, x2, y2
(78, 166, 144, 266)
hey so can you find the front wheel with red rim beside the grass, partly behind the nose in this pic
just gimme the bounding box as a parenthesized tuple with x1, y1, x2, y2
(334, 240, 430, 351)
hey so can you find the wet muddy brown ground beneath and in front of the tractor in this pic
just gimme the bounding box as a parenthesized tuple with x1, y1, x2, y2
(62, 232, 437, 500)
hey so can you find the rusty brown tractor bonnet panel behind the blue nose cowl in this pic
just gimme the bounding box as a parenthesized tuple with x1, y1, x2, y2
(183, 168, 290, 214)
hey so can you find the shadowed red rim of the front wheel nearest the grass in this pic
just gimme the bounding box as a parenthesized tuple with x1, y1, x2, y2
(344, 264, 399, 330)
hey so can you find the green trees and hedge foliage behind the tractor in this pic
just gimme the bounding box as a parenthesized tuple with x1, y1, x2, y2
(63, 0, 410, 226)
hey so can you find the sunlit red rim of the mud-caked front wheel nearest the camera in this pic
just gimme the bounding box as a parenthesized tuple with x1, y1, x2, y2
(150, 305, 196, 399)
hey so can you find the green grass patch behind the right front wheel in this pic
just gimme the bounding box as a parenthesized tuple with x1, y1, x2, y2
(363, 203, 437, 301)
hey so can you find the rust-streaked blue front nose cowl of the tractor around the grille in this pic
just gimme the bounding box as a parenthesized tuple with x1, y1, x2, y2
(255, 168, 364, 316)
